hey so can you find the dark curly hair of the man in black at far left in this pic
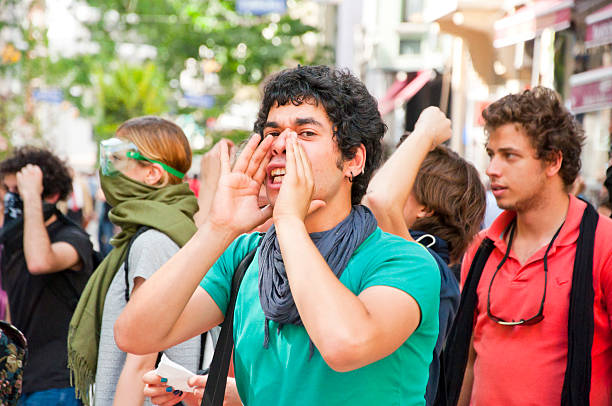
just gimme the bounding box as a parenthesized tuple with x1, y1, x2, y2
(0, 146, 72, 200)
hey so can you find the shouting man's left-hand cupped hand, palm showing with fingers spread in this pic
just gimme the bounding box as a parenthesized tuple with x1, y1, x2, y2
(207, 134, 273, 234)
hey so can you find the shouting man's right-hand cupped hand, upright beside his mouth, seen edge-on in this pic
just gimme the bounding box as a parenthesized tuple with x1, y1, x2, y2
(273, 130, 325, 222)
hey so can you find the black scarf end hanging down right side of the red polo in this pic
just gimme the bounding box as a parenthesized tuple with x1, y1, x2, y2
(561, 202, 599, 406)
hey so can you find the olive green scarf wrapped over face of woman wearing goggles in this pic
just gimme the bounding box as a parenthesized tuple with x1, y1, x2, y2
(68, 174, 198, 404)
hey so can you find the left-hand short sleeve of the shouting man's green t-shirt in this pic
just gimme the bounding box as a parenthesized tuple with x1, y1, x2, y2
(200, 233, 261, 315)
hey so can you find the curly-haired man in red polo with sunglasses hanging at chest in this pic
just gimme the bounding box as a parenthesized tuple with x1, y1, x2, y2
(447, 87, 612, 406)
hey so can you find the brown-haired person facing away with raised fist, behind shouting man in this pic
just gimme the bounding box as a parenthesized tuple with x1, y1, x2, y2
(363, 107, 485, 405)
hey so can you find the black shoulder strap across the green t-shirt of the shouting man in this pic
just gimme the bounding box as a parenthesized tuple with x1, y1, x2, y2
(201, 239, 261, 406)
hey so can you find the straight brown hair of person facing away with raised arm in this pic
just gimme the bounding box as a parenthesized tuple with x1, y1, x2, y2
(400, 136, 486, 264)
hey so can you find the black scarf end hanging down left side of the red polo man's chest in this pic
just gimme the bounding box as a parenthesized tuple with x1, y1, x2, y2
(434, 238, 495, 406)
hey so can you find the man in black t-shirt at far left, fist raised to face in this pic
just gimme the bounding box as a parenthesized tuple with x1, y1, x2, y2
(0, 147, 93, 406)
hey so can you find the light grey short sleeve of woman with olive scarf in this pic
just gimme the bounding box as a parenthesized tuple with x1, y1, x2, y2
(128, 230, 179, 291)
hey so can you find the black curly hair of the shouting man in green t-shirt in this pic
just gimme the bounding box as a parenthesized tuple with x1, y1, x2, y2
(254, 66, 387, 204)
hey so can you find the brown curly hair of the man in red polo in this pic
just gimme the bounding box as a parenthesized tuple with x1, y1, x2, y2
(482, 86, 585, 187)
